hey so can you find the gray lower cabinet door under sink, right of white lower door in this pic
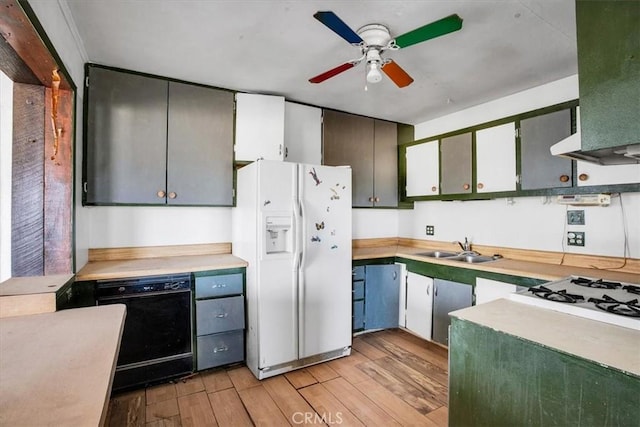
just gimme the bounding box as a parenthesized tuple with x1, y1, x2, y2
(432, 279, 472, 346)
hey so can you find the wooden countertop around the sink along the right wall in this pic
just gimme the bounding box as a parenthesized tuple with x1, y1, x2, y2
(353, 245, 640, 283)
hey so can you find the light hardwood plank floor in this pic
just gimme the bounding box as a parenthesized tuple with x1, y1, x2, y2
(107, 329, 448, 427)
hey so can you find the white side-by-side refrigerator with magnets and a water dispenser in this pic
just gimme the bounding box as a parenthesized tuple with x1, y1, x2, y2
(232, 160, 351, 379)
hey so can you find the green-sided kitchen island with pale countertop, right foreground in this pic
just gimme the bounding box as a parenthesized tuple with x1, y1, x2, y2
(449, 299, 640, 426)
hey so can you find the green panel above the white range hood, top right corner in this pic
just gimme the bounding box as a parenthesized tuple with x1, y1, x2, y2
(576, 0, 640, 151)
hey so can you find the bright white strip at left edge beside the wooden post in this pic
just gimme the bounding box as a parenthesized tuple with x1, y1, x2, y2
(0, 71, 13, 282)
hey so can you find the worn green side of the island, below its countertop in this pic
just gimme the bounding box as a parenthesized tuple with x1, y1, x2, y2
(449, 318, 640, 427)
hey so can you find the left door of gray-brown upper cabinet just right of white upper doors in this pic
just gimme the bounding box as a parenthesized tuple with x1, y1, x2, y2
(323, 110, 373, 207)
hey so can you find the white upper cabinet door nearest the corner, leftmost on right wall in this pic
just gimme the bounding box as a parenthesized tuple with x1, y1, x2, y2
(406, 141, 440, 197)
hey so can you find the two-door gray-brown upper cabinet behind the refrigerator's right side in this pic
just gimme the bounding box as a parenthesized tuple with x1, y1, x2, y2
(323, 110, 398, 207)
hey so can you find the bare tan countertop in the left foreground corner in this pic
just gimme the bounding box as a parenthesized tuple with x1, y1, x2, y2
(0, 304, 126, 426)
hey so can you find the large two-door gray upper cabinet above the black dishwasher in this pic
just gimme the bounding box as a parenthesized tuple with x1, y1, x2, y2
(84, 66, 234, 206)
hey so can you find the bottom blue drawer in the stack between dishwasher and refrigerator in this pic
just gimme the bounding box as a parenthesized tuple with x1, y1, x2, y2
(196, 330, 244, 371)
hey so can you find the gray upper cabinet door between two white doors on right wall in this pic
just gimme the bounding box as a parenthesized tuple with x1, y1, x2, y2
(440, 132, 472, 194)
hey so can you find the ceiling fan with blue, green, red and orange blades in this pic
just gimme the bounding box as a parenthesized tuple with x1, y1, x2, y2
(309, 11, 462, 88)
